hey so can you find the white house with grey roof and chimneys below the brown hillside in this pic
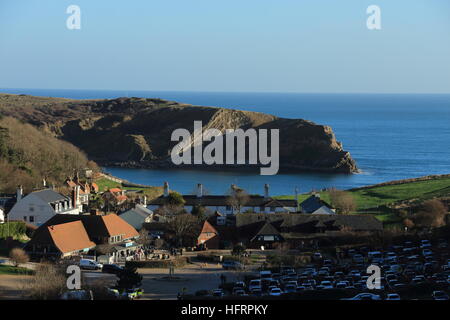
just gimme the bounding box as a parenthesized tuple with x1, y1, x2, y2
(8, 187, 80, 226)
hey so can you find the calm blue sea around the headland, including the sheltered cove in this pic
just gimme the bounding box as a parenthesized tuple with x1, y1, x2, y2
(0, 89, 450, 194)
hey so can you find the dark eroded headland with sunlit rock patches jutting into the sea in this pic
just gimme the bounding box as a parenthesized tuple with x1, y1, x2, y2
(0, 95, 357, 173)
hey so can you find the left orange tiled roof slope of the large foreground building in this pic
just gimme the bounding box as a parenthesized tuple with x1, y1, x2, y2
(47, 221, 95, 253)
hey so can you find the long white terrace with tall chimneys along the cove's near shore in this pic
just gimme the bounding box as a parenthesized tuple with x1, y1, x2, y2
(149, 182, 298, 214)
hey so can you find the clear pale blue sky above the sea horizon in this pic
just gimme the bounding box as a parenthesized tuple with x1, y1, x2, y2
(0, 0, 450, 93)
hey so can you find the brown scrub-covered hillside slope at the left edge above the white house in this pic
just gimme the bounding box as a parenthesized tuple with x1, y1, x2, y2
(0, 117, 95, 192)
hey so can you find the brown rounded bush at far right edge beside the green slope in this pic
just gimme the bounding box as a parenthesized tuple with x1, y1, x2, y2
(414, 199, 448, 228)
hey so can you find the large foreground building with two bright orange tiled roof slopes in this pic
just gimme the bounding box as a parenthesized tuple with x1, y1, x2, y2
(25, 214, 140, 261)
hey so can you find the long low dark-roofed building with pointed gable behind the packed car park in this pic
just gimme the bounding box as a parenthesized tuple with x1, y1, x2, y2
(202, 213, 383, 249)
